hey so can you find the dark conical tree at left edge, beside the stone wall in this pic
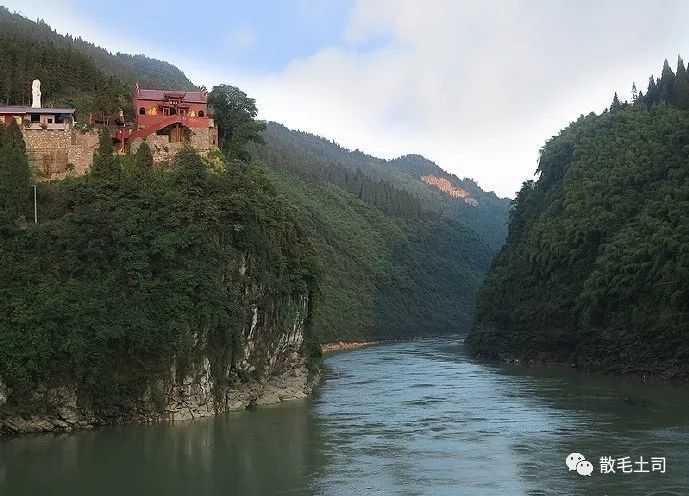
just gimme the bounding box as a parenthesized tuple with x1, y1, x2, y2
(0, 122, 32, 219)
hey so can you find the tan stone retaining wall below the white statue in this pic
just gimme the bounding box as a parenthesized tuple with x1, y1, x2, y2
(22, 129, 98, 180)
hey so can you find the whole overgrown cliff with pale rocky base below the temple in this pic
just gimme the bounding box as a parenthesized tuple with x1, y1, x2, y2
(0, 150, 320, 434)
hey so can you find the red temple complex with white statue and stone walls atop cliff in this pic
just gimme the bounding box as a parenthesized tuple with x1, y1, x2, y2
(0, 80, 218, 179)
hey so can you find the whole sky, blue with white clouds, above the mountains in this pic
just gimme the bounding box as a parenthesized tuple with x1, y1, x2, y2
(0, 0, 689, 197)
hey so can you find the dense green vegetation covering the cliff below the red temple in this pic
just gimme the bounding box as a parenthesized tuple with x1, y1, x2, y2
(0, 128, 319, 416)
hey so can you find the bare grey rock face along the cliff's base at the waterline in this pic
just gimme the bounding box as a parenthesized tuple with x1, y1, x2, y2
(0, 262, 319, 435)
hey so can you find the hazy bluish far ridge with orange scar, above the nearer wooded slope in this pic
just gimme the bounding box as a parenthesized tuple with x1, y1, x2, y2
(260, 122, 509, 249)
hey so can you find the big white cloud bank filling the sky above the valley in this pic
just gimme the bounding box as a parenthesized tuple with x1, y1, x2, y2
(230, 0, 689, 195)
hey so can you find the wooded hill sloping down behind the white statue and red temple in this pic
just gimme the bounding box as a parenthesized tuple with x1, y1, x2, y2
(0, 6, 195, 118)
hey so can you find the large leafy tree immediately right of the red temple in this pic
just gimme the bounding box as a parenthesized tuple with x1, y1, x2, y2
(208, 84, 266, 162)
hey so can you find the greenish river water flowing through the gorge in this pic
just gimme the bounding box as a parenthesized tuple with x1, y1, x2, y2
(0, 339, 689, 496)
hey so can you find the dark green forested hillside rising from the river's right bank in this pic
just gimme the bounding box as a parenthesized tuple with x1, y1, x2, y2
(468, 59, 689, 379)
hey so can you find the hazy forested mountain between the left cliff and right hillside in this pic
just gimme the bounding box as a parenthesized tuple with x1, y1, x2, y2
(251, 123, 508, 341)
